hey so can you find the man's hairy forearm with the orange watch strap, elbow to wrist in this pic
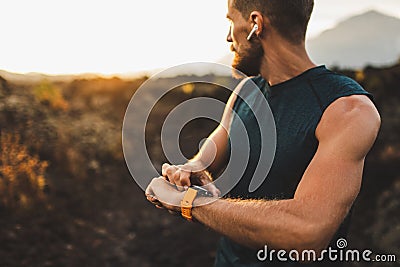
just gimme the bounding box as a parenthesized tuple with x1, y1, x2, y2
(192, 199, 330, 250)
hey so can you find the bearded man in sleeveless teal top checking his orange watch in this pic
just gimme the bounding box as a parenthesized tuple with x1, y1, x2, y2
(146, 0, 380, 266)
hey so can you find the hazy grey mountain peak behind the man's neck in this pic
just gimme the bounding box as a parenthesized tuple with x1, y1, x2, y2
(307, 11, 400, 68)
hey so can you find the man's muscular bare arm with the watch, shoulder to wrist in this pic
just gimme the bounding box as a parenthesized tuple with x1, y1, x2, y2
(192, 96, 380, 251)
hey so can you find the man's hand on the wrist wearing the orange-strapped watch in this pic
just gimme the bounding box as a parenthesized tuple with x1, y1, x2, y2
(145, 177, 185, 212)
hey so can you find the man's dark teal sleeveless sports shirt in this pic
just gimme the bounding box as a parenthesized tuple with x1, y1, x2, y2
(216, 66, 372, 267)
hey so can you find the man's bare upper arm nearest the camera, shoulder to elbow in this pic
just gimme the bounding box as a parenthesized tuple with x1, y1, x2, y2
(295, 96, 380, 241)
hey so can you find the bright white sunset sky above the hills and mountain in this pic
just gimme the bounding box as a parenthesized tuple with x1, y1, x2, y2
(0, 0, 400, 74)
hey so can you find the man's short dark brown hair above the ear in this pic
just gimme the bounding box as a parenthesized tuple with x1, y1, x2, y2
(233, 0, 314, 44)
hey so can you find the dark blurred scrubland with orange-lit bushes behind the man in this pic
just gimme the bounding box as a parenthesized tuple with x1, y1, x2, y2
(0, 64, 400, 266)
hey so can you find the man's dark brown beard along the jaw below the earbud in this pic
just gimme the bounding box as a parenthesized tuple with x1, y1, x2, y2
(231, 39, 264, 77)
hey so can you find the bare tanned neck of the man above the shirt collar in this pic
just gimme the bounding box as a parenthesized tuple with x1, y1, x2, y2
(260, 37, 316, 85)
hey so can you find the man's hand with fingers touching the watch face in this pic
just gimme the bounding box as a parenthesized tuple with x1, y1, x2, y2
(162, 162, 221, 197)
